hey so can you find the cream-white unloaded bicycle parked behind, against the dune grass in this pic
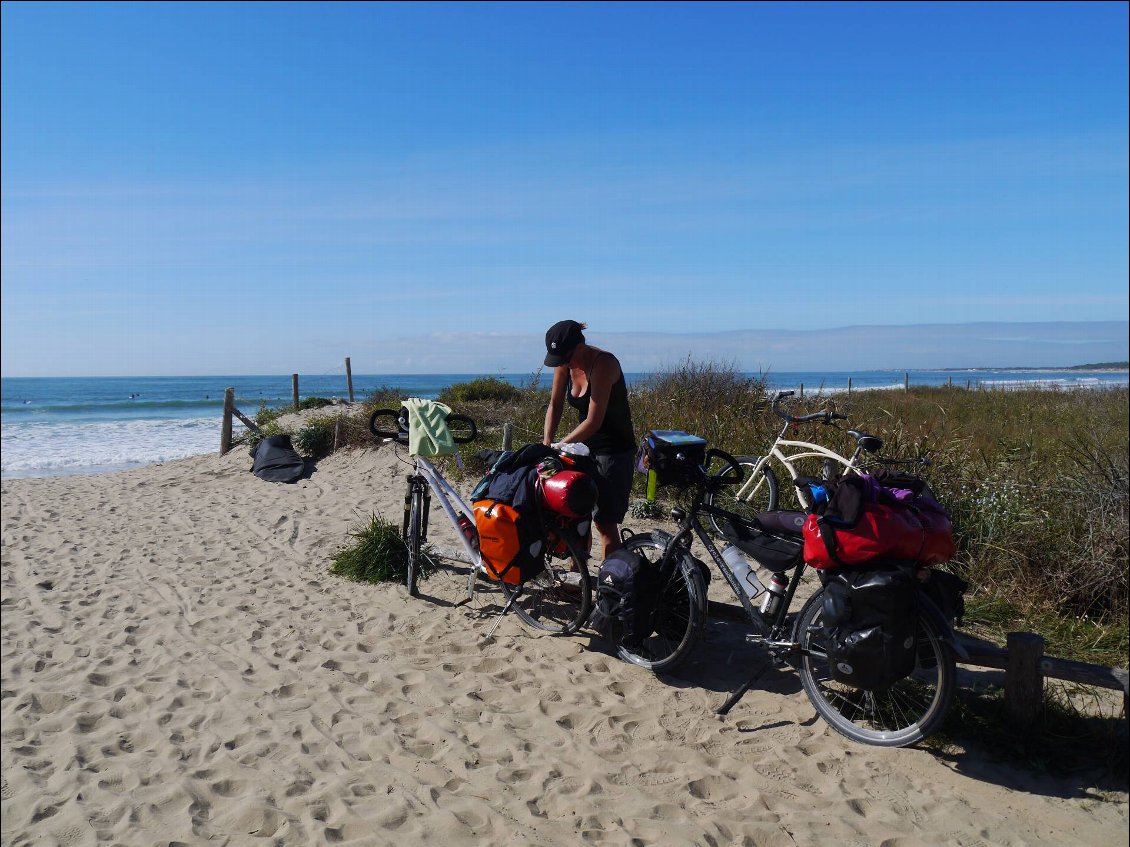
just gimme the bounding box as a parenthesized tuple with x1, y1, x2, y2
(705, 391, 894, 534)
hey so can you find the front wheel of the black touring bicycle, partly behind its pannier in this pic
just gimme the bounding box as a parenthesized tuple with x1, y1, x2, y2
(617, 530, 706, 673)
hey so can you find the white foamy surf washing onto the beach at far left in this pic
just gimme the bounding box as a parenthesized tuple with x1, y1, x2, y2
(0, 417, 245, 479)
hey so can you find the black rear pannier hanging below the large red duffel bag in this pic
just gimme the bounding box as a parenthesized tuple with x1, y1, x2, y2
(823, 566, 918, 690)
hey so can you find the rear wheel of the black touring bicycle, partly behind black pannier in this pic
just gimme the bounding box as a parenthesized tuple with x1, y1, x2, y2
(793, 590, 956, 746)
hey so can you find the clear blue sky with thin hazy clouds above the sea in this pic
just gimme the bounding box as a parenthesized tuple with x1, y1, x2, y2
(0, 1, 1130, 376)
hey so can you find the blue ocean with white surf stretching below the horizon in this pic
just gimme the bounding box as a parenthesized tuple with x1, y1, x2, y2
(0, 370, 1128, 479)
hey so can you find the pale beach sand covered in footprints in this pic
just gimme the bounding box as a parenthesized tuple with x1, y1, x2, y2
(0, 446, 1128, 847)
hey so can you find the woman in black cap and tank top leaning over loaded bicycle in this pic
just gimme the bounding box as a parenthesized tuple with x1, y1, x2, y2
(541, 321, 636, 559)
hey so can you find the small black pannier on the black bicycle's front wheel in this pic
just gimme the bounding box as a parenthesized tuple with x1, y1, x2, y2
(589, 548, 659, 644)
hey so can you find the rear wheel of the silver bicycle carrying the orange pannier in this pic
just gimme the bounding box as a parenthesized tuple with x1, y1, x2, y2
(501, 536, 592, 635)
